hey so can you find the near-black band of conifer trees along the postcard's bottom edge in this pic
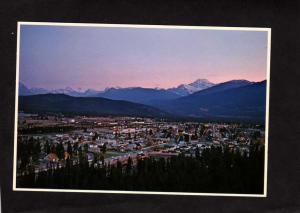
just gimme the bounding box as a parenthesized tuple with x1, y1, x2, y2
(17, 144, 264, 194)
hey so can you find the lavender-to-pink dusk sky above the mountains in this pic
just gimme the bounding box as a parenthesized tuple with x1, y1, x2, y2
(19, 25, 267, 90)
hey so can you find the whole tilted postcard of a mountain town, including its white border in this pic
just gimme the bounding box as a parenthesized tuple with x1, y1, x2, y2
(13, 22, 271, 197)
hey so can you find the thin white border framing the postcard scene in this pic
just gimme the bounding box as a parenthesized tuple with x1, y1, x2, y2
(12, 21, 271, 197)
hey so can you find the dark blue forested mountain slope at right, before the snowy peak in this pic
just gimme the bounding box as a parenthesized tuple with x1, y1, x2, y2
(154, 80, 266, 121)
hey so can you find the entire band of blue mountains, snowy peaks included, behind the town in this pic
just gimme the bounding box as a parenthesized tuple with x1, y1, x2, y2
(19, 79, 266, 121)
